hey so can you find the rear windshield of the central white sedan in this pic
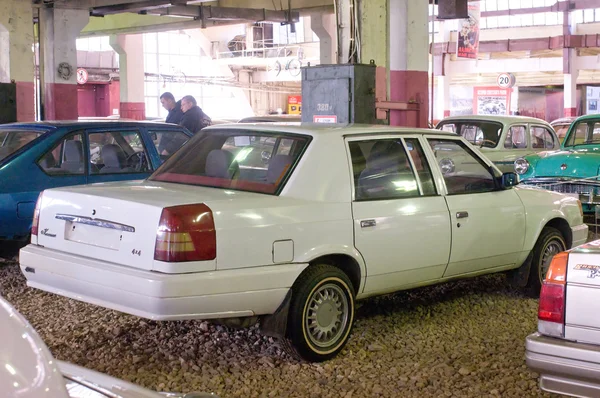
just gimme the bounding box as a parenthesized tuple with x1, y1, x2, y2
(149, 129, 310, 194)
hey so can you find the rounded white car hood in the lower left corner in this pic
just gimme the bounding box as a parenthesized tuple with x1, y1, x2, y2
(0, 297, 68, 398)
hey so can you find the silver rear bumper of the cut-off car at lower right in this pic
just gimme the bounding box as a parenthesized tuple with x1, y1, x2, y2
(525, 333, 600, 397)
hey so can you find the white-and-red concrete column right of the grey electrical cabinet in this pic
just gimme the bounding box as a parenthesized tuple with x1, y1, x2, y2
(388, 0, 429, 127)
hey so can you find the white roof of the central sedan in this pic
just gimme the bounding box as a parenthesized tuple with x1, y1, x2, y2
(204, 123, 458, 137)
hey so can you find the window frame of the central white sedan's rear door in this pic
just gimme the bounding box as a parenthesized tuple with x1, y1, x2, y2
(344, 133, 441, 202)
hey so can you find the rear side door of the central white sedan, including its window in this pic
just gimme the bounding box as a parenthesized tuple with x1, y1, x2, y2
(347, 136, 451, 294)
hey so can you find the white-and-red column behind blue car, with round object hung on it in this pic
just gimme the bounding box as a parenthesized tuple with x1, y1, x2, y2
(40, 8, 90, 120)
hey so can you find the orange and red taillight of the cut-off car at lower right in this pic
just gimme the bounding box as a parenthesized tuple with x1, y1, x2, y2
(538, 252, 569, 337)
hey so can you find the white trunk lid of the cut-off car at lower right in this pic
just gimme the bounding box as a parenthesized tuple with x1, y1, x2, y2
(565, 241, 600, 344)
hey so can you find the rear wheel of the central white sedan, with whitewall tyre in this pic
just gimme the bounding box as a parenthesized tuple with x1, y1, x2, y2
(283, 264, 354, 362)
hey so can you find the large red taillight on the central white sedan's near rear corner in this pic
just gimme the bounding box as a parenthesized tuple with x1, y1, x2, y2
(154, 203, 217, 262)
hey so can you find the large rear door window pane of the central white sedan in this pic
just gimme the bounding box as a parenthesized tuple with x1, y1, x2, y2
(349, 138, 420, 200)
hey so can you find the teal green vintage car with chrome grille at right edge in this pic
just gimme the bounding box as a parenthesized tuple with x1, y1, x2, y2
(515, 115, 600, 212)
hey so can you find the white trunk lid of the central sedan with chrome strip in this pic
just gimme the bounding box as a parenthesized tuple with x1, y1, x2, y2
(37, 181, 263, 271)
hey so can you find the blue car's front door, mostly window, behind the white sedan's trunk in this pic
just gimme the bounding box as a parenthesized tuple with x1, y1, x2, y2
(87, 127, 153, 184)
